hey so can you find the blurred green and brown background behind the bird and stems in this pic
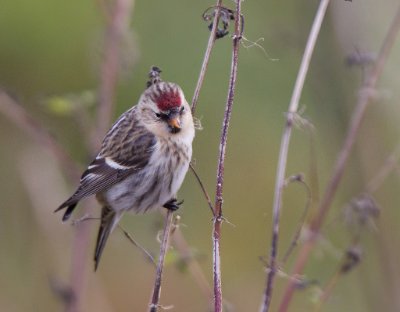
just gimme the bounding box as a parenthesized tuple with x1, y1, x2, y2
(0, 0, 400, 312)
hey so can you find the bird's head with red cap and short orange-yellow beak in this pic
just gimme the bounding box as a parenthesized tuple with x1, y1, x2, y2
(138, 81, 193, 137)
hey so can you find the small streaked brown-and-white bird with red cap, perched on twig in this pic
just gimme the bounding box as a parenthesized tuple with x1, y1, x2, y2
(56, 67, 195, 270)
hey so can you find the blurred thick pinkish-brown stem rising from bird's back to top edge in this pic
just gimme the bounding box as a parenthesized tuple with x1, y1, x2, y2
(97, 0, 133, 139)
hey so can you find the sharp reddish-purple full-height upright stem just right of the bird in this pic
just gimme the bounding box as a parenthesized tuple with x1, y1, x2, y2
(212, 0, 242, 312)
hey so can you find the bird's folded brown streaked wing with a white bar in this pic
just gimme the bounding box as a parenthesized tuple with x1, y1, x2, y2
(56, 110, 156, 216)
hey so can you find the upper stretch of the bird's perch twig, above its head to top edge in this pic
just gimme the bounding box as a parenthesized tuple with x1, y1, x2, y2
(192, 0, 222, 115)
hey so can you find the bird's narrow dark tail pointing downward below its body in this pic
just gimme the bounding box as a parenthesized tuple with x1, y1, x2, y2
(94, 206, 122, 271)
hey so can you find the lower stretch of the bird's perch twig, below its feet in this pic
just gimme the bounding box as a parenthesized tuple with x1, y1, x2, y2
(149, 210, 174, 312)
